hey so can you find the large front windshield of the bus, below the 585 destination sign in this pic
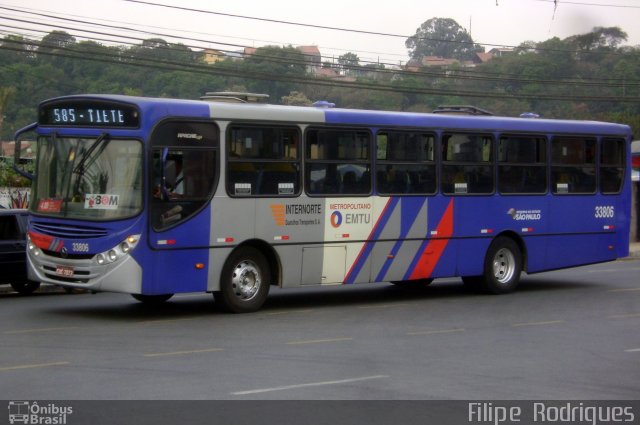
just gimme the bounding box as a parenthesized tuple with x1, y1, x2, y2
(31, 133, 143, 220)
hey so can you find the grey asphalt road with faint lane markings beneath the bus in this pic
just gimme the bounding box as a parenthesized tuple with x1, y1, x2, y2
(0, 260, 640, 400)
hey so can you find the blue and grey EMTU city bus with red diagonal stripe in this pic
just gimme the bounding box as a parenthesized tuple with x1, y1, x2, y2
(16, 95, 632, 312)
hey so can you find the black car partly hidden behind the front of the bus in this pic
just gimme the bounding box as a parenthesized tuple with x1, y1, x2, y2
(0, 209, 40, 294)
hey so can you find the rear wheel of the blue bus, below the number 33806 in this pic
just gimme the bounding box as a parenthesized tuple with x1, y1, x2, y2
(478, 236, 522, 294)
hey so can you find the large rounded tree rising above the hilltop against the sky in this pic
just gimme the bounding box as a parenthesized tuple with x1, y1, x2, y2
(405, 18, 484, 60)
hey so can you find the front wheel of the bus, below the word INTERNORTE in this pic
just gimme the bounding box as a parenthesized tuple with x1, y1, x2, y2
(213, 246, 271, 313)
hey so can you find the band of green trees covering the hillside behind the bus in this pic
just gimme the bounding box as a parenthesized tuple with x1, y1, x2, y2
(0, 27, 640, 137)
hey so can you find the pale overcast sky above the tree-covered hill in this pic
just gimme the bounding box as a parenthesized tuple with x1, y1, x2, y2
(0, 0, 640, 64)
